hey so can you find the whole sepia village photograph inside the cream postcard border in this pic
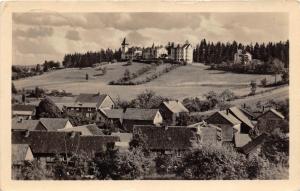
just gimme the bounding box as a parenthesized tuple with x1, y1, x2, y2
(7, 10, 295, 181)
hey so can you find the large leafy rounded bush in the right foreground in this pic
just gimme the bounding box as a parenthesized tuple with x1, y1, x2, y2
(176, 146, 247, 180)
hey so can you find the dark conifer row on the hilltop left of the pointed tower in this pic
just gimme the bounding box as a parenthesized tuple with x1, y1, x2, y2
(62, 48, 122, 68)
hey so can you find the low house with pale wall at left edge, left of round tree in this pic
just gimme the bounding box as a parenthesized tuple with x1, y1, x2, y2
(12, 104, 36, 119)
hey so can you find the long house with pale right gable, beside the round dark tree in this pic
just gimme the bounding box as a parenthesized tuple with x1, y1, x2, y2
(64, 93, 115, 119)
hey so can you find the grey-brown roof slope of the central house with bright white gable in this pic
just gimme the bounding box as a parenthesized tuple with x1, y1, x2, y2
(123, 108, 159, 121)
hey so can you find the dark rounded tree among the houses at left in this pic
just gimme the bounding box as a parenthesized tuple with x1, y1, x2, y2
(36, 97, 63, 118)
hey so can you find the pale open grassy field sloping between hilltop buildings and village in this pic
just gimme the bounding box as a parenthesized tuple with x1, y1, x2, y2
(14, 63, 286, 100)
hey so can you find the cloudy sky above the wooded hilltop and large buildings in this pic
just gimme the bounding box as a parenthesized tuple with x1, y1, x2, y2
(12, 12, 289, 65)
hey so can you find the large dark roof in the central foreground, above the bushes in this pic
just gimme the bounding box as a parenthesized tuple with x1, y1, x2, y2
(133, 125, 197, 150)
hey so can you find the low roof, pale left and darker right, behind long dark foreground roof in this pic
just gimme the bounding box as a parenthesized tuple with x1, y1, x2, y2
(58, 124, 104, 136)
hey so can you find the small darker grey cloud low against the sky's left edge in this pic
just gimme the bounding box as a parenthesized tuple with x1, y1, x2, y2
(13, 26, 53, 38)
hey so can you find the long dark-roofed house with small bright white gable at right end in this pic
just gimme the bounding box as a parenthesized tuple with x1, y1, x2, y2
(122, 108, 163, 132)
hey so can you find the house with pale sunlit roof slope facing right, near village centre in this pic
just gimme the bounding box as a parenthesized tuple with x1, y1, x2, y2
(159, 100, 189, 125)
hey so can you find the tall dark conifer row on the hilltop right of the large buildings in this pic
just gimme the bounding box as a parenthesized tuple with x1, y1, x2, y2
(193, 39, 289, 68)
